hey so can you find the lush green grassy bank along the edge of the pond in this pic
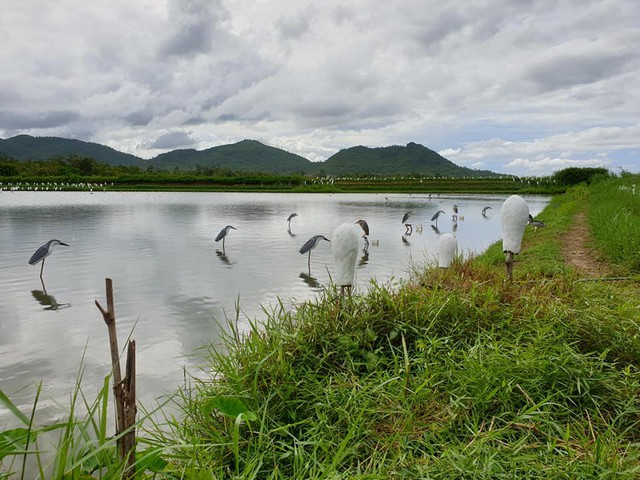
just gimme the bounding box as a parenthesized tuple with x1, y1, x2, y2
(0, 174, 640, 479)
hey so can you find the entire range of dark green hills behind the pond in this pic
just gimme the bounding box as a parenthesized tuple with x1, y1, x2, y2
(0, 135, 499, 177)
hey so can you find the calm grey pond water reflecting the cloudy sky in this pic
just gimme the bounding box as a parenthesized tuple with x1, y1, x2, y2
(0, 191, 549, 427)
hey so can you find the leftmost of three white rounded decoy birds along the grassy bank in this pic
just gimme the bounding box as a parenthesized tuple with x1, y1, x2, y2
(331, 223, 362, 295)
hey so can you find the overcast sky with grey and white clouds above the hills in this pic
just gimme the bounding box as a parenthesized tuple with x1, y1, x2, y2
(0, 0, 640, 175)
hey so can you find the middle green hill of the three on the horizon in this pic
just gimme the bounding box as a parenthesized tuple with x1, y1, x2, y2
(149, 140, 316, 174)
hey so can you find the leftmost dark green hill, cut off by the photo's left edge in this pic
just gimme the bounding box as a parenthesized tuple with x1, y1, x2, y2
(0, 135, 148, 168)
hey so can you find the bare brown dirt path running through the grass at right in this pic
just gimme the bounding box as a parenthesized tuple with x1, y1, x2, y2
(560, 212, 611, 278)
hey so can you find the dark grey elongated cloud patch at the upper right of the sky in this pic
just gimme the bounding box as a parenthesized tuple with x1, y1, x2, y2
(526, 53, 632, 93)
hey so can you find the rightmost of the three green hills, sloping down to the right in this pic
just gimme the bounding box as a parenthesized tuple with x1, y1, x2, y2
(322, 142, 497, 177)
